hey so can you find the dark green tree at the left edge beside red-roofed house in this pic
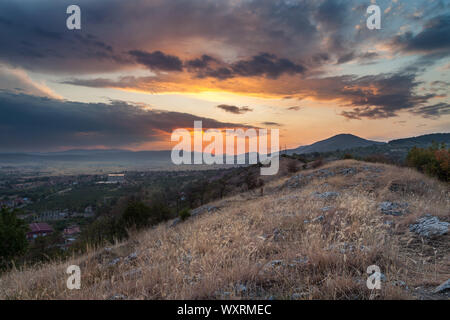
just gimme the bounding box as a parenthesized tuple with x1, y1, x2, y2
(0, 207, 28, 266)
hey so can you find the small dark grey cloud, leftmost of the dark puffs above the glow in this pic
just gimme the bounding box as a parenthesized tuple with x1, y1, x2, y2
(129, 50, 183, 71)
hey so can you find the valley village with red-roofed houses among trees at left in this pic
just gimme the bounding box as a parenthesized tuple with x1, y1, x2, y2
(0, 170, 127, 250)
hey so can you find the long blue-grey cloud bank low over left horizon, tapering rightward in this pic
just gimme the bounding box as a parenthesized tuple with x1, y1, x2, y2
(0, 92, 250, 151)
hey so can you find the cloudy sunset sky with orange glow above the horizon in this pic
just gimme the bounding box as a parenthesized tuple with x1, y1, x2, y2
(0, 0, 450, 152)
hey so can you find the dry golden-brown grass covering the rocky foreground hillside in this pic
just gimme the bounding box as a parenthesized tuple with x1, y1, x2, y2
(0, 160, 450, 299)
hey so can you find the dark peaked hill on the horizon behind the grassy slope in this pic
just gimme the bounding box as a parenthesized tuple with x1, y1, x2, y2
(288, 134, 386, 154)
